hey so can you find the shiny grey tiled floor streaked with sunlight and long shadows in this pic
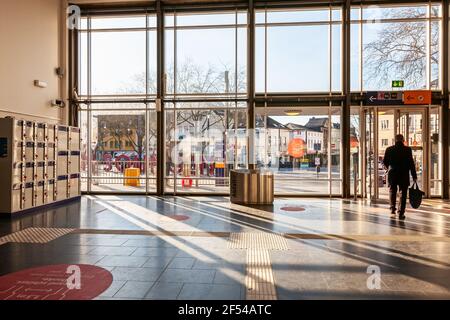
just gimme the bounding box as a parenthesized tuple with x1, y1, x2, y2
(0, 196, 450, 300)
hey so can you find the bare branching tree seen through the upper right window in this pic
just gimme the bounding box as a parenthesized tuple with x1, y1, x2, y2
(363, 7, 439, 88)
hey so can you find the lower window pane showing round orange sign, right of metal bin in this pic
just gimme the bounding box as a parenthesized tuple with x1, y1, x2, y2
(254, 107, 342, 196)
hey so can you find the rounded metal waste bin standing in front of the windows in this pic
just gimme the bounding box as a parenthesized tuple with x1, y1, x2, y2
(230, 170, 274, 204)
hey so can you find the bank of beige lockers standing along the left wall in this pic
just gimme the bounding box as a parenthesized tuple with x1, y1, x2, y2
(0, 117, 81, 214)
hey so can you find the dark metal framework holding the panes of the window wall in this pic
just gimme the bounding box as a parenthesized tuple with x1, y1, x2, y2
(69, 0, 450, 199)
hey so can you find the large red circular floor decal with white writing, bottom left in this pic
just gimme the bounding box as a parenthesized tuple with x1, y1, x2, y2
(0, 264, 113, 300)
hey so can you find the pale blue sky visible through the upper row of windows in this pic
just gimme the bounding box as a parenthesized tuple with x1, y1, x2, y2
(81, 8, 440, 100)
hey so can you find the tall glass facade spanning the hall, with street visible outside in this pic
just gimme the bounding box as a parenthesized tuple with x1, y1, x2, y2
(76, 2, 443, 196)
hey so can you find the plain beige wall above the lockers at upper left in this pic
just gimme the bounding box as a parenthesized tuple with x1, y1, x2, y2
(0, 0, 66, 123)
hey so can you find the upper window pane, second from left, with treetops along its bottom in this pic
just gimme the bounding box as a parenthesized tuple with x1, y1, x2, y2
(165, 12, 247, 96)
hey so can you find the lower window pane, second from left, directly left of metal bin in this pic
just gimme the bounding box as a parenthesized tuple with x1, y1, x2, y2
(165, 104, 247, 193)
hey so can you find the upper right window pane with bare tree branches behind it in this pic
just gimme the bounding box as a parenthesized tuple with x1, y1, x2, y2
(351, 4, 442, 91)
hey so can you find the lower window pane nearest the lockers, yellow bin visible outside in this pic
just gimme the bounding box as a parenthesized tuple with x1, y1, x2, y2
(91, 110, 146, 192)
